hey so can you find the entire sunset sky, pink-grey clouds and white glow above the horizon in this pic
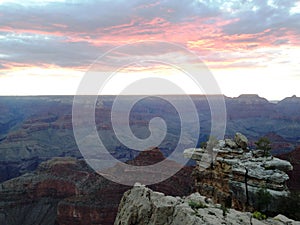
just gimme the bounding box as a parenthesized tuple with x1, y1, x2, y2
(0, 0, 300, 100)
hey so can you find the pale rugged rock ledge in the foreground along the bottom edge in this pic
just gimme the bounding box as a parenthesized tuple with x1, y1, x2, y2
(114, 184, 300, 225)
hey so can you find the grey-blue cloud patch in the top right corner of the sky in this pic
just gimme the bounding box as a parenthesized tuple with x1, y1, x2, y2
(223, 0, 300, 35)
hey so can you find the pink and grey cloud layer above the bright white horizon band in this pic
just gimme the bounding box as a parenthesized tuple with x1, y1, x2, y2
(0, 0, 300, 98)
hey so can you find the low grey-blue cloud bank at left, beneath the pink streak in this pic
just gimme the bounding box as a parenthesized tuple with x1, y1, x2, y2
(0, 31, 111, 67)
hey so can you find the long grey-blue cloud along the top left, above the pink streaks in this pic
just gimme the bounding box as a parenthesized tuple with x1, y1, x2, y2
(0, 0, 217, 36)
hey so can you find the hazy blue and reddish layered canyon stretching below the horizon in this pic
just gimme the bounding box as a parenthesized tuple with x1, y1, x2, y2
(0, 95, 300, 225)
